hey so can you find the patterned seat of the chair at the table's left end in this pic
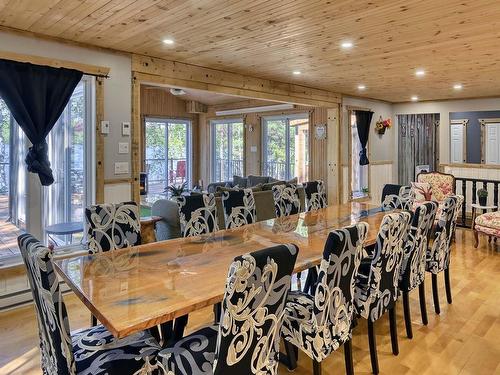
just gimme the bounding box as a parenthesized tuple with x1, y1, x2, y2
(71, 325, 161, 375)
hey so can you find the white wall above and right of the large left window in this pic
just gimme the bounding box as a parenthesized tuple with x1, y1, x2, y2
(0, 32, 132, 182)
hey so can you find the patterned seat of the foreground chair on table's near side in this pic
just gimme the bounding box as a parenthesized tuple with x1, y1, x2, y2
(158, 325, 219, 375)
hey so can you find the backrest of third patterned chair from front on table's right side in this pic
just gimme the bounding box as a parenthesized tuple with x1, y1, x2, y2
(360, 211, 411, 321)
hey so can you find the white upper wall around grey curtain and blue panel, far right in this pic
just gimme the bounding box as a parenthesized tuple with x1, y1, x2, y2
(393, 98, 500, 164)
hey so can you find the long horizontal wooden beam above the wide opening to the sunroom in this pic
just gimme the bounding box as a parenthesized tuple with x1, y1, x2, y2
(132, 54, 341, 107)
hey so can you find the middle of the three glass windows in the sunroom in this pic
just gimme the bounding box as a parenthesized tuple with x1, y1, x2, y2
(210, 119, 245, 182)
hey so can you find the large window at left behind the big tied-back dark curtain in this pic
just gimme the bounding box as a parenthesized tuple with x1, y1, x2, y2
(0, 76, 95, 261)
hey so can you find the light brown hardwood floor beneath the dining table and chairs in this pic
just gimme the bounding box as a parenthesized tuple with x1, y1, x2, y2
(0, 229, 500, 375)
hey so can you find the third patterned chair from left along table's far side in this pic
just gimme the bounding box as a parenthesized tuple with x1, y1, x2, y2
(222, 189, 257, 229)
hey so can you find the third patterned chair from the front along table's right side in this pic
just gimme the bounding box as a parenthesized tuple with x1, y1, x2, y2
(355, 211, 411, 374)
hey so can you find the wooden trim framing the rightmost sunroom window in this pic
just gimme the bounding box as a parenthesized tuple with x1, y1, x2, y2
(260, 112, 311, 181)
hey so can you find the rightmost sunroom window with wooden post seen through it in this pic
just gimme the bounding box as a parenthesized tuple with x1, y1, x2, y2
(262, 114, 309, 183)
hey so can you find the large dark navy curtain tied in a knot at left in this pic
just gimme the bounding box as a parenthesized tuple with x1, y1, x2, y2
(0, 59, 83, 186)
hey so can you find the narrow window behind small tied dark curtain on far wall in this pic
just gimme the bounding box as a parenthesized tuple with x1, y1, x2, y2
(349, 111, 369, 199)
